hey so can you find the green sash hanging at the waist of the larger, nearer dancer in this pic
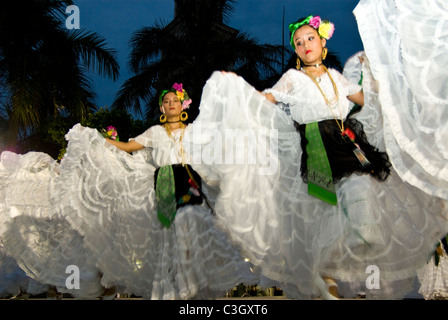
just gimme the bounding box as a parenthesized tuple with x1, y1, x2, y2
(305, 122, 338, 205)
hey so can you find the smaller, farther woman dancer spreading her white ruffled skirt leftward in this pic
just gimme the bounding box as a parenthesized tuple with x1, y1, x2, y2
(1, 84, 257, 299)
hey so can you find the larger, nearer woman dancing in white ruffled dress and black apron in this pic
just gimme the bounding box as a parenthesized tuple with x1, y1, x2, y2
(186, 12, 447, 299)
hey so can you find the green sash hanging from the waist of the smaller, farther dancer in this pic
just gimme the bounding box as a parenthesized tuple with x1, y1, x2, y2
(156, 166, 177, 228)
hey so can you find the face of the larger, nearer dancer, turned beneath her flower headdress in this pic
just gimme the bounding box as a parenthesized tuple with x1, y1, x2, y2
(293, 25, 327, 64)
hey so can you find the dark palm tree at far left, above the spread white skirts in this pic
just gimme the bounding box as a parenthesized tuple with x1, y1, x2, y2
(0, 0, 119, 148)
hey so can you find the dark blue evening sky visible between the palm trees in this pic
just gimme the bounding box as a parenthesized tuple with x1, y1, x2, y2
(72, 0, 363, 114)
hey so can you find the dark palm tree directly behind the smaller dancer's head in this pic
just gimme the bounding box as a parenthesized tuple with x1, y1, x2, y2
(113, 0, 281, 119)
